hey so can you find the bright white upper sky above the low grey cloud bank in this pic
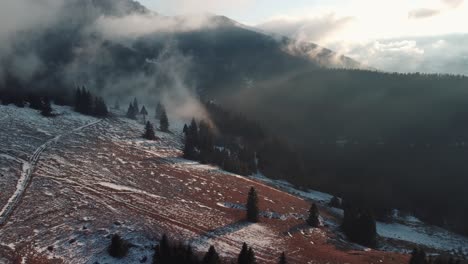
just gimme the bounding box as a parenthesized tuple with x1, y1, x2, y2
(141, 0, 468, 41)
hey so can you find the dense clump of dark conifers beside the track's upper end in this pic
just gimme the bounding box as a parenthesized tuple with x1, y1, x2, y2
(75, 87, 109, 117)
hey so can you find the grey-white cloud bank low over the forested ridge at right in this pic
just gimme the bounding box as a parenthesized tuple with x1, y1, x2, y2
(331, 35, 468, 75)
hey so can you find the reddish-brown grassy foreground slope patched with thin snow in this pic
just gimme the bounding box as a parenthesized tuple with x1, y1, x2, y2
(0, 106, 464, 263)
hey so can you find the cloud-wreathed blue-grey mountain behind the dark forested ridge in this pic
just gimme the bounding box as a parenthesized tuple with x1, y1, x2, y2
(2, 0, 359, 101)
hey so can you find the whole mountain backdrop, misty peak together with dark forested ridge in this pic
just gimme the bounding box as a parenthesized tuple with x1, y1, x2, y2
(0, 0, 468, 256)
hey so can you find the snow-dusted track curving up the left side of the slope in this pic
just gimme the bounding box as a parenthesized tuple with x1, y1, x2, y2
(0, 119, 102, 226)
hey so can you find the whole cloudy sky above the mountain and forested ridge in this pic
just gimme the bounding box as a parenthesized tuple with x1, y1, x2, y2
(141, 0, 468, 75)
